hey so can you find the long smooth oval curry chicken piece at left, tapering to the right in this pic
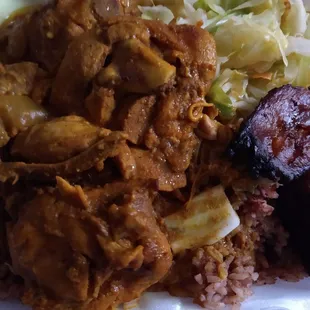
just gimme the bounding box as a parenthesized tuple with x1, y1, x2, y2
(11, 116, 106, 164)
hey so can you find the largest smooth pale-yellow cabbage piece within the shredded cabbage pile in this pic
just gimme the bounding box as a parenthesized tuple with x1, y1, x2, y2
(214, 11, 288, 71)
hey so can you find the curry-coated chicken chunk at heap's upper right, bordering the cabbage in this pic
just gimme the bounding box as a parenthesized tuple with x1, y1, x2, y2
(144, 20, 216, 97)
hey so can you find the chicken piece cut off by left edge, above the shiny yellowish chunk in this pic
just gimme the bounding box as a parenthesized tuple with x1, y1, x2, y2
(0, 62, 38, 95)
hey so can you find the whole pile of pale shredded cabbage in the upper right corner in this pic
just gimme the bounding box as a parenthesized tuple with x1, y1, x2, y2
(141, 0, 310, 119)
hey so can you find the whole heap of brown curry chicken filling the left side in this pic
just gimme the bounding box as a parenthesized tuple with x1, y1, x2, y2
(0, 0, 216, 310)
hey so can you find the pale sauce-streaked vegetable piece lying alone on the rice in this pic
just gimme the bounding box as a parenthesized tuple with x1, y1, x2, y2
(164, 185, 240, 253)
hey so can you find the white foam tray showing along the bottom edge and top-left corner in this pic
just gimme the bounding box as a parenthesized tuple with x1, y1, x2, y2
(0, 0, 310, 310)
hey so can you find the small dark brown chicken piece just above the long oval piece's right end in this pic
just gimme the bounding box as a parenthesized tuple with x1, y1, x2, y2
(85, 87, 116, 126)
